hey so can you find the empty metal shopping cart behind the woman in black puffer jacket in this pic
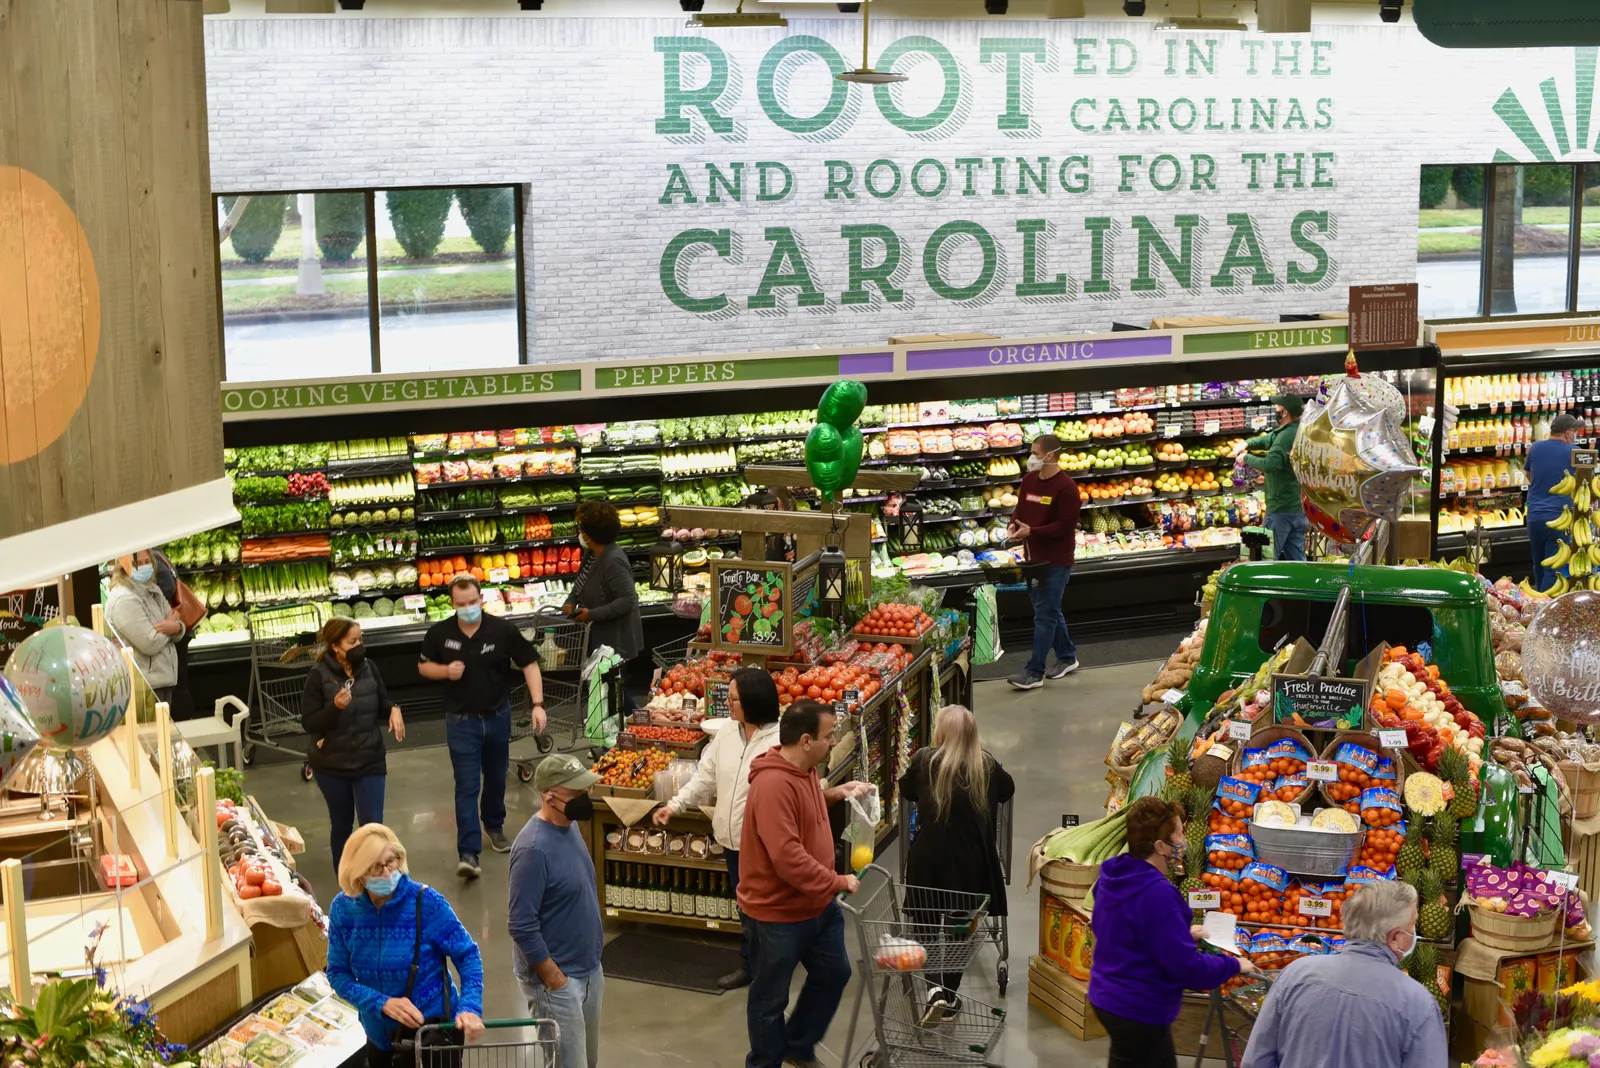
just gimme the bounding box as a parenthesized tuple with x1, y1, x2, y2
(242, 604, 326, 782)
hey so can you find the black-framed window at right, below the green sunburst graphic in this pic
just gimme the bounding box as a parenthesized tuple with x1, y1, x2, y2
(1418, 163, 1600, 318)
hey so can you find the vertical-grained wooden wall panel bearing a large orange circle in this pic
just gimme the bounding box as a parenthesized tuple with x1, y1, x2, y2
(0, 0, 222, 537)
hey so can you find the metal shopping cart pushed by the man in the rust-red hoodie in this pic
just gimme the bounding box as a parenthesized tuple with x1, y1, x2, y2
(840, 865, 1005, 1068)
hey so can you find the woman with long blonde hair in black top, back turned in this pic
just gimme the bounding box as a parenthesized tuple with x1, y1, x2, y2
(899, 705, 1016, 1015)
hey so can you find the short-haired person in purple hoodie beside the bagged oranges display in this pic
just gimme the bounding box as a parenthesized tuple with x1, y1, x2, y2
(1090, 798, 1256, 1068)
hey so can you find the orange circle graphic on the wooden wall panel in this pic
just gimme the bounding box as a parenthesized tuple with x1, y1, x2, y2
(0, 166, 101, 464)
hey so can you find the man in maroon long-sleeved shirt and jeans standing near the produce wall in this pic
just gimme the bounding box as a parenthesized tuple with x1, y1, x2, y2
(1006, 433, 1083, 689)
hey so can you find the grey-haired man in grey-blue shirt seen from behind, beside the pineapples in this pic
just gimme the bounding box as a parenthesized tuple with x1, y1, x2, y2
(1235, 879, 1448, 1068)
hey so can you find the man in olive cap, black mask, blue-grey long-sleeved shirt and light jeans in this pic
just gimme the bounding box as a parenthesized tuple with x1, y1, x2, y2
(509, 753, 605, 1068)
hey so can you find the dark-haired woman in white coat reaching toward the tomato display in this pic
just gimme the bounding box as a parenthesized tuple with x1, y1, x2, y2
(653, 668, 779, 990)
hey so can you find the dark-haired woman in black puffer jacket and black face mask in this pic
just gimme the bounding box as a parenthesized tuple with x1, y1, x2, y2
(301, 616, 405, 868)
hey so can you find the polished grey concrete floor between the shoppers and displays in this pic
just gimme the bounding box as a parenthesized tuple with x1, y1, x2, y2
(246, 664, 1160, 1068)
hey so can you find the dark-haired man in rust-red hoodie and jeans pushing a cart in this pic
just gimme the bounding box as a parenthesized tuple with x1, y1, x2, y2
(739, 700, 870, 1068)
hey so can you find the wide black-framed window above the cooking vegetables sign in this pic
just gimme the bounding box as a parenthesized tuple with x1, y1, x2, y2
(216, 185, 525, 382)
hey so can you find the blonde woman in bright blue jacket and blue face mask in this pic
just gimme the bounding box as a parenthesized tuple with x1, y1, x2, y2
(328, 823, 483, 1068)
